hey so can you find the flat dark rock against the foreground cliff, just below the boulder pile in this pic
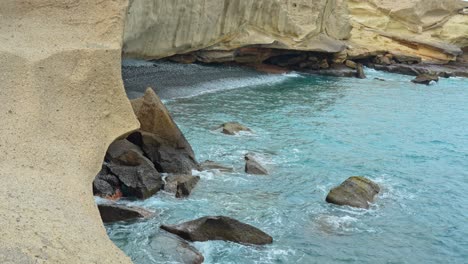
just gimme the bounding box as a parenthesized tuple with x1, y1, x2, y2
(98, 204, 154, 223)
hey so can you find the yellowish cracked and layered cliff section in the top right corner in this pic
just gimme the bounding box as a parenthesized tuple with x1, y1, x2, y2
(347, 0, 468, 62)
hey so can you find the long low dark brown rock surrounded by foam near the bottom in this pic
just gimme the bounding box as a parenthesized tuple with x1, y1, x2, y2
(161, 216, 273, 245)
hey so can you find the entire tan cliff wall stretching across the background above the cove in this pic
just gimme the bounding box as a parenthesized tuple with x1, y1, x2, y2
(124, 0, 468, 62)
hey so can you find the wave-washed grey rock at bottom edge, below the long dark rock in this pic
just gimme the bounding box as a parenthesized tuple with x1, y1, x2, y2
(150, 234, 205, 264)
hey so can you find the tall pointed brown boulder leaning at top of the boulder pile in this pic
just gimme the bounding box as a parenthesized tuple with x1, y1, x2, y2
(129, 88, 198, 174)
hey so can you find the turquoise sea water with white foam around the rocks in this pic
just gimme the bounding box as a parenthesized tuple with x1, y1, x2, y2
(107, 63, 468, 263)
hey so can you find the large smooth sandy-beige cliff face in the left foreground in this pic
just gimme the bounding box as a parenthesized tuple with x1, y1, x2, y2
(0, 0, 138, 264)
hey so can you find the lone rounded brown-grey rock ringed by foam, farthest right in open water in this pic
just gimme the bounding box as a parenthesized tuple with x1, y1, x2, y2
(326, 176, 380, 209)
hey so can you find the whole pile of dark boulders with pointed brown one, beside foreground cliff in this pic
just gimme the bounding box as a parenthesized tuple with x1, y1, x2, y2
(93, 88, 199, 200)
